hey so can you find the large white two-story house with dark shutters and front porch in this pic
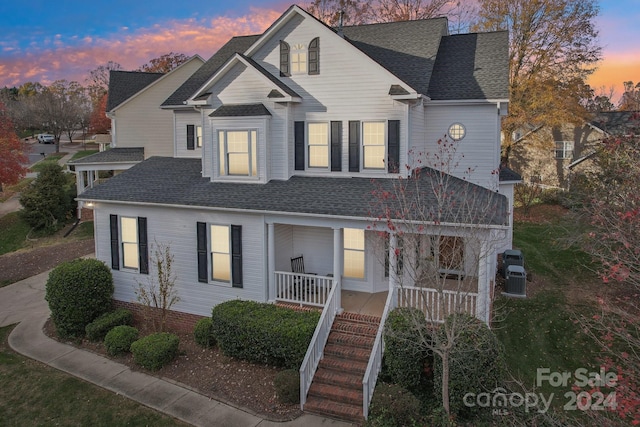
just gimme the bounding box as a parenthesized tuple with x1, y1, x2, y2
(78, 6, 519, 422)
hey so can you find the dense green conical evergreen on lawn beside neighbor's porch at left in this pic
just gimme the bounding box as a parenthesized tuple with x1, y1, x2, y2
(20, 162, 75, 234)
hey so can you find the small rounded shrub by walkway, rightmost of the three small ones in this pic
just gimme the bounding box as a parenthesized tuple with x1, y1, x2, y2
(131, 332, 180, 371)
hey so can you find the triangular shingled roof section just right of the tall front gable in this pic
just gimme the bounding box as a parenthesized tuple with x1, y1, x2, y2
(343, 18, 448, 94)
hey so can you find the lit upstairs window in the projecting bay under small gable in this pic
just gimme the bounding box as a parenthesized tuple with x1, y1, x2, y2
(218, 130, 258, 176)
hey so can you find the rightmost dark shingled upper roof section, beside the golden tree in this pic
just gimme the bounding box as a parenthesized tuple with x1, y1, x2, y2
(426, 31, 509, 100)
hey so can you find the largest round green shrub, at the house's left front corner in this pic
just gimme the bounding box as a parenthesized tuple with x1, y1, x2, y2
(45, 259, 113, 338)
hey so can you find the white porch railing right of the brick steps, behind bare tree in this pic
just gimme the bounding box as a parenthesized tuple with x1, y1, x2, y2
(397, 286, 483, 323)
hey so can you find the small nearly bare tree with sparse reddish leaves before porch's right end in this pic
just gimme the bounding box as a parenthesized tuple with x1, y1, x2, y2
(372, 140, 508, 413)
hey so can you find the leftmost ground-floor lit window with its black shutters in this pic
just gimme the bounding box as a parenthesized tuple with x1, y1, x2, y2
(109, 215, 149, 274)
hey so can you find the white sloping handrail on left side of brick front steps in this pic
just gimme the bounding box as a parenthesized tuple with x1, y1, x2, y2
(300, 280, 341, 410)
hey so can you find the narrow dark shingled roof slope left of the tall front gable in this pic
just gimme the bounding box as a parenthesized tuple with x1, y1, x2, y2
(162, 35, 260, 107)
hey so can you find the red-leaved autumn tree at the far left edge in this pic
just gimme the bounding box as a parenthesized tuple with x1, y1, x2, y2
(0, 102, 28, 191)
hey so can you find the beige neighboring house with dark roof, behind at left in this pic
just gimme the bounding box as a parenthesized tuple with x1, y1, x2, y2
(69, 55, 204, 219)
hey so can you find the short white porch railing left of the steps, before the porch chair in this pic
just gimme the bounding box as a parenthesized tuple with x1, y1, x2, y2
(275, 271, 333, 307)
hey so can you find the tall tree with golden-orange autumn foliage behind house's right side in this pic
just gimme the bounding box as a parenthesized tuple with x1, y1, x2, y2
(475, 0, 601, 162)
